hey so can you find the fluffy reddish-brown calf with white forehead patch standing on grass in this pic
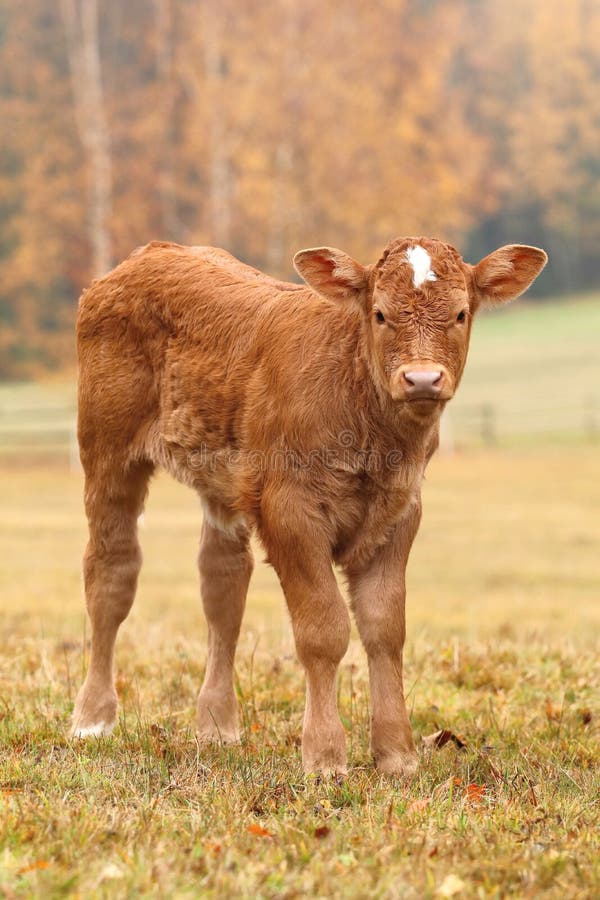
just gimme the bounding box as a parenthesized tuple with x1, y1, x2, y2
(73, 238, 547, 775)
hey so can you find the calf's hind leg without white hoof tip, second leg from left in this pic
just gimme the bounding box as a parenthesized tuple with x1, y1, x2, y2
(196, 520, 253, 743)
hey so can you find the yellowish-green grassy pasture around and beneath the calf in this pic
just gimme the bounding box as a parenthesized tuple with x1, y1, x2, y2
(0, 298, 600, 898)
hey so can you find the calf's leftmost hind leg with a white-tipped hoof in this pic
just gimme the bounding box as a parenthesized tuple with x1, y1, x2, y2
(72, 462, 153, 737)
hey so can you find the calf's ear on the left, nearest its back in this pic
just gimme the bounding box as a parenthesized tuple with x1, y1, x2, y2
(294, 247, 369, 301)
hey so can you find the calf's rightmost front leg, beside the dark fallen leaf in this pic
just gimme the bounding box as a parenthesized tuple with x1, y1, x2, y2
(347, 503, 421, 777)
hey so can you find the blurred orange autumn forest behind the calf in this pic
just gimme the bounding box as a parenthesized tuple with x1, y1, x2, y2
(0, 0, 600, 378)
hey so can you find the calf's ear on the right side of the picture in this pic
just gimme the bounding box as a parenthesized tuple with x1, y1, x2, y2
(472, 244, 548, 306)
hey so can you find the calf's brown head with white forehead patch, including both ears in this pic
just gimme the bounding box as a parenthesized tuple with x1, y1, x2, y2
(294, 238, 548, 417)
